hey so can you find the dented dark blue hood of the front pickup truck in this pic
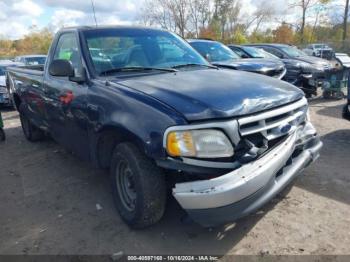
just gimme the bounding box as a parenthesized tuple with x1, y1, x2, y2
(114, 69, 303, 121)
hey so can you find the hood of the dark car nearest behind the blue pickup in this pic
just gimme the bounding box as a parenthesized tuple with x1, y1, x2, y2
(212, 58, 284, 73)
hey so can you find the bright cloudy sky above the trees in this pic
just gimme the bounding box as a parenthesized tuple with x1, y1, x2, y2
(0, 0, 340, 39)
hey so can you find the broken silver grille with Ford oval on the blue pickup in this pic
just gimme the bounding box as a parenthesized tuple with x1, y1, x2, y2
(238, 98, 308, 141)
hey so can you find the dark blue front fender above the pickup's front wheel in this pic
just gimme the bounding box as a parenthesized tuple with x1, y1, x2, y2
(88, 81, 187, 159)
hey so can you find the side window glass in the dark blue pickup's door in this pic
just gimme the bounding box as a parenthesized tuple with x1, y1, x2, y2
(54, 33, 82, 76)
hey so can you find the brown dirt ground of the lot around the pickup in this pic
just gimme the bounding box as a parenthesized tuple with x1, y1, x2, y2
(0, 99, 350, 255)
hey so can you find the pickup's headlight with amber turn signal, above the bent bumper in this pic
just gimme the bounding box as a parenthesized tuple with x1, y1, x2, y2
(166, 129, 234, 158)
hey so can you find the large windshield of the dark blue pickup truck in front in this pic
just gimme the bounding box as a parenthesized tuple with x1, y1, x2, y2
(84, 28, 208, 74)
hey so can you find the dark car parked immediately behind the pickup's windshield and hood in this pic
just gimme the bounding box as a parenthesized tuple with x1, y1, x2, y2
(188, 39, 286, 79)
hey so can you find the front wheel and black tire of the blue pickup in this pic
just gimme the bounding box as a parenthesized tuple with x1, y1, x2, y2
(110, 143, 167, 229)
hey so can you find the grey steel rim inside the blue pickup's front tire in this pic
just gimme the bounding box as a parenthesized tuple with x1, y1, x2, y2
(115, 160, 137, 212)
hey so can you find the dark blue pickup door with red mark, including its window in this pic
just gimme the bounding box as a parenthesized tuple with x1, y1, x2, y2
(45, 32, 89, 160)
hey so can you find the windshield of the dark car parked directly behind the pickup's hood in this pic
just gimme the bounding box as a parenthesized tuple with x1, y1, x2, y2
(190, 41, 240, 62)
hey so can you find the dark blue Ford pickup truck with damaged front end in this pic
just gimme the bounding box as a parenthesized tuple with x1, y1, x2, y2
(8, 27, 322, 228)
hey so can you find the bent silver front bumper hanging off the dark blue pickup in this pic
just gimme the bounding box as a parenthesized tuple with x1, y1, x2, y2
(173, 123, 322, 227)
